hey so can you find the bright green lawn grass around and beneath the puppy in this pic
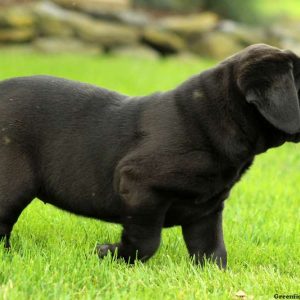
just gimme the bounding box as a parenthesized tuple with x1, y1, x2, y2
(0, 52, 300, 300)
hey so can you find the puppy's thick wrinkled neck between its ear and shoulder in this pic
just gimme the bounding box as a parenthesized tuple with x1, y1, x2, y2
(172, 63, 286, 161)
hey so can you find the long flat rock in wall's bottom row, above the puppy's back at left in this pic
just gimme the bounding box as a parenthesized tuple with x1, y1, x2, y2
(33, 37, 103, 55)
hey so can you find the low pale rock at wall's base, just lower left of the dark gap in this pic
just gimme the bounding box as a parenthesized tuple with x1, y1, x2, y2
(110, 45, 160, 60)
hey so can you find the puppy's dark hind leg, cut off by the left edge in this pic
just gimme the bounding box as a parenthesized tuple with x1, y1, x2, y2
(0, 144, 36, 248)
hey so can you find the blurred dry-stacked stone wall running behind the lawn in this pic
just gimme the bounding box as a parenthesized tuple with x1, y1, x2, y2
(0, 0, 300, 59)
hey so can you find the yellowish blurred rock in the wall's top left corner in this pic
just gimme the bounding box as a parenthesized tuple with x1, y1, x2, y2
(0, 5, 36, 28)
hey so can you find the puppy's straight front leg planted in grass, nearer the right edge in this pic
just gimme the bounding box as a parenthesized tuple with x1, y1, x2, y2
(182, 210, 227, 268)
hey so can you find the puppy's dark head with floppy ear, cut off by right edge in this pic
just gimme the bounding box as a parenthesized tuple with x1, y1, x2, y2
(232, 44, 300, 135)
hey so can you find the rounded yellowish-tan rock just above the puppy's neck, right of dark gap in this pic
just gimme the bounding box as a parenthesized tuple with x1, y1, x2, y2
(191, 31, 244, 60)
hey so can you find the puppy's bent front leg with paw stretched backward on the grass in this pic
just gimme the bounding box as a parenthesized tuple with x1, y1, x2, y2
(97, 168, 169, 263)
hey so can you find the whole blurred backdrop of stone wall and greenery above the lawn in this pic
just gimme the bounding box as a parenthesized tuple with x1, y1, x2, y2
(0, 0, 300, 60)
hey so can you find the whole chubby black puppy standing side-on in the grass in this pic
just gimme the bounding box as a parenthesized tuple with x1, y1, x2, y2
(0, 44, 300, 267)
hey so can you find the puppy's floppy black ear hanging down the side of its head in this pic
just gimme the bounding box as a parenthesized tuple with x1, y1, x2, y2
(245, 71, 300, 134)
